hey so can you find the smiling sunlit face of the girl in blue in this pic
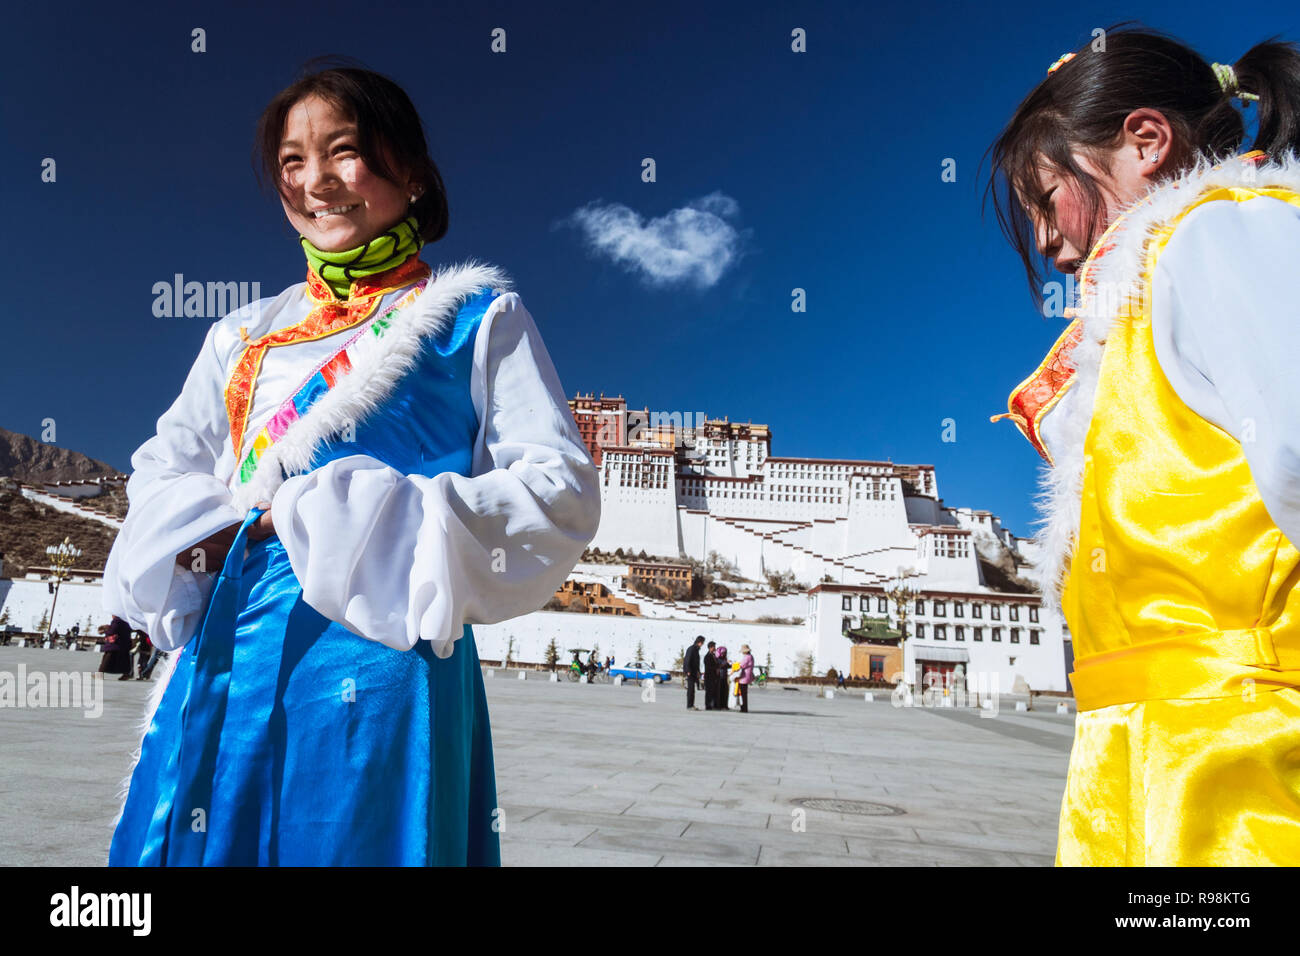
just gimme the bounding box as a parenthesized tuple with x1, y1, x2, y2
(280, 95, 419, 252)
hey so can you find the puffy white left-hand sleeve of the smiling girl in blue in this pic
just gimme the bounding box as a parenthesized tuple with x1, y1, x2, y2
(104, 324, 241, 650)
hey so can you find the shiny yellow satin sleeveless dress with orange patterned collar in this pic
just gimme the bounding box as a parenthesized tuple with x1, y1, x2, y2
(1013, 166, 1300, 866)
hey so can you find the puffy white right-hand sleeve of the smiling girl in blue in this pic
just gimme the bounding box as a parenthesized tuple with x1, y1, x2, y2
(272, 293, 601, 657)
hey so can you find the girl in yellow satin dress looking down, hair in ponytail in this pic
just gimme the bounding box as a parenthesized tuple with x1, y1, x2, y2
(989, 29, 1300, 865)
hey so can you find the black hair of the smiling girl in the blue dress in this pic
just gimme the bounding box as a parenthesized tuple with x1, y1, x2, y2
(254, 57, 450, 242)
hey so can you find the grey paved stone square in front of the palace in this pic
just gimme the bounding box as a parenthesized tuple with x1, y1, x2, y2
(0, 648, 1074, 866)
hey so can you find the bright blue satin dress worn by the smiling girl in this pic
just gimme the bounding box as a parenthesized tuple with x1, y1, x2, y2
(108, 290, 501, 866)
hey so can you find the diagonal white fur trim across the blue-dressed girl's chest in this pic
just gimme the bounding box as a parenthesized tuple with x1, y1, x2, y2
(231, 261, 510, 514)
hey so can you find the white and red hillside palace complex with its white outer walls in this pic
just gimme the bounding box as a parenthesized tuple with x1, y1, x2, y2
(0, 394, 1069, 693)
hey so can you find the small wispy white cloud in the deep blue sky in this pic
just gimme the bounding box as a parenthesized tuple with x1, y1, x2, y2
(569, 193, 741, 289)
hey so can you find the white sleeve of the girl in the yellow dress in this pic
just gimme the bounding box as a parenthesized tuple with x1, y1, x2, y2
(1152, 196, 1300, 546)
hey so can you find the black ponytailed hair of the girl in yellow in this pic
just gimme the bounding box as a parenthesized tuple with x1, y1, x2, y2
(984, 23, 1300, 300)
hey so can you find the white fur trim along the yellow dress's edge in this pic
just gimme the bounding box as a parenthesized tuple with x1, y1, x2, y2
(1035, 156, 1300, 611)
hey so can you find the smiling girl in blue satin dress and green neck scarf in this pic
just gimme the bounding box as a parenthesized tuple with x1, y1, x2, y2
(104, 63, 601, 866)
